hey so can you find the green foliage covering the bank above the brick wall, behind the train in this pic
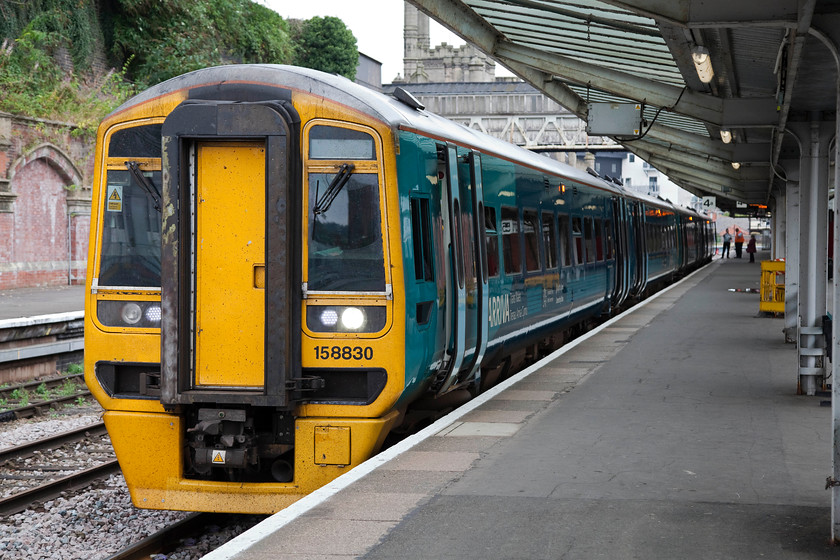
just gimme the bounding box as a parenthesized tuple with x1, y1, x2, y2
(0, 0, 358, 125)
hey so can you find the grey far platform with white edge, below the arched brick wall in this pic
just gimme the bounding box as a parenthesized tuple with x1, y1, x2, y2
(0, 285, 85, 321)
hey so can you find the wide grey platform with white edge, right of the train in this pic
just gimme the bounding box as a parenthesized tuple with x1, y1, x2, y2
(204, 254, 840, 560)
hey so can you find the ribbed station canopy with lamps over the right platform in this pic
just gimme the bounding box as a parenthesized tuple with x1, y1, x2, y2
(410, 0, 840, 214)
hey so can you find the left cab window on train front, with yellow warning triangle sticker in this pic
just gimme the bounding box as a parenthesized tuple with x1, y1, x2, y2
(97, 124, 162, 288)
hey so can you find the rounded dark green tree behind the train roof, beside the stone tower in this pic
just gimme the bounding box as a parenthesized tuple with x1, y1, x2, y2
(294, 16, 359, 80)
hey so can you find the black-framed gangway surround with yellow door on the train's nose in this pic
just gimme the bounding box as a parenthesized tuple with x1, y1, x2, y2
(161, 100, 301, 408)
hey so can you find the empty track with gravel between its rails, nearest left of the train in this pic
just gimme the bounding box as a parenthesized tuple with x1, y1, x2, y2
(0, 422, 119, 516)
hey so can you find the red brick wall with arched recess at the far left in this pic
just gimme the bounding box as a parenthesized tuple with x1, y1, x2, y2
(0, 113, 93, 290)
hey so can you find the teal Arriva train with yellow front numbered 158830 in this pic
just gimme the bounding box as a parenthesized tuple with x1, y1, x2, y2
(85, 65, 715, 514)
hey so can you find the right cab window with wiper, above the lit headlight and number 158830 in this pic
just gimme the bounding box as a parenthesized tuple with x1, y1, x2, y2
(305, 125, 384, 292)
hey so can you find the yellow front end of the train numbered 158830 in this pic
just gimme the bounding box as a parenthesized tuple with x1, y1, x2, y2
(85, 66, 405, 513)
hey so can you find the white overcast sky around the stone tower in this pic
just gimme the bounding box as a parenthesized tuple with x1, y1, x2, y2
(258, 0, 472, 83)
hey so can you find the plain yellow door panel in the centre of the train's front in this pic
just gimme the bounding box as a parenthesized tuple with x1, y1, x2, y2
(195, 142, 265, 388)
